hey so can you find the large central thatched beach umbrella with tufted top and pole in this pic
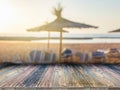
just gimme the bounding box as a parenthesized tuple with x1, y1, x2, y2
(28, 4, 97, 61)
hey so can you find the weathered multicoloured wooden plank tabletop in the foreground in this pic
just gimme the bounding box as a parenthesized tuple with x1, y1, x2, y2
(0, 65, 120, 90)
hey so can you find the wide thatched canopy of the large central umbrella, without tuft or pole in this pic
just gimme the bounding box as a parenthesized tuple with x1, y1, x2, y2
(28, 17, 97, 32)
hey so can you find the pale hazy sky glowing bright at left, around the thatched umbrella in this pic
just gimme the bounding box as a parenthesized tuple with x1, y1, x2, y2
(0, 0, 120, 35)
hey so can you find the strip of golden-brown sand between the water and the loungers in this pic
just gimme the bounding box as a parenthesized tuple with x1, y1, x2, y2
(0, 41, 120, 53)
